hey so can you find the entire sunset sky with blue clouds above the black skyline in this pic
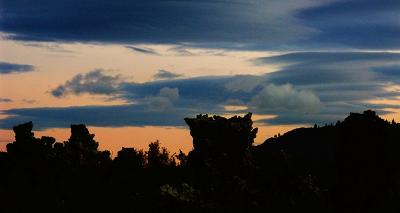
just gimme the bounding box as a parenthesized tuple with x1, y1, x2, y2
(0, 0, 400, 153)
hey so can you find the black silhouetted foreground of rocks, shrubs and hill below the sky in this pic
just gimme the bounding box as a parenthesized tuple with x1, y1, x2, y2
(0, 111, 400, 213)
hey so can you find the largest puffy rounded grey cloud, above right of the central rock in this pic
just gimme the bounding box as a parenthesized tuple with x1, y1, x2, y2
(249, 84, 321, 113)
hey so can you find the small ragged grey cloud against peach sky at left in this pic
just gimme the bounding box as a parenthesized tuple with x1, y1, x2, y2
(51, 69, 123, 97)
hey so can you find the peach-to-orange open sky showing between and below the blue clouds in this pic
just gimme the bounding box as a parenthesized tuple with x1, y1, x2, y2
(0, 40, 400, 156)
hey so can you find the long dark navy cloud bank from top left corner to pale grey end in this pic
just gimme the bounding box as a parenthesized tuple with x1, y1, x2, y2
(0, 0, 326, 49)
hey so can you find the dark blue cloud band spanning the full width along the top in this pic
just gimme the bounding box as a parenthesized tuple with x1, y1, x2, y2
(0, 0, 400, 49)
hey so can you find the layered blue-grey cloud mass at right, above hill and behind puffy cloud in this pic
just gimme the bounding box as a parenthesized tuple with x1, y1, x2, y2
(248, 52, 400, 124)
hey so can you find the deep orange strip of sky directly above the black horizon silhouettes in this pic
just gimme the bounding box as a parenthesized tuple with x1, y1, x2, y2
(0, 124, 299, 157)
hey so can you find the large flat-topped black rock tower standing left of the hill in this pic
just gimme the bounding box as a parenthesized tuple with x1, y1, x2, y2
(185, 113, 258, 173)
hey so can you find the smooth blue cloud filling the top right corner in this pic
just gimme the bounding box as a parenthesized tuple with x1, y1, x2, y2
(297, 0, 400, 50)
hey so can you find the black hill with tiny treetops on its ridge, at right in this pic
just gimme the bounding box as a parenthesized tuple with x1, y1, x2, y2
(254, 110, 400, 212)
